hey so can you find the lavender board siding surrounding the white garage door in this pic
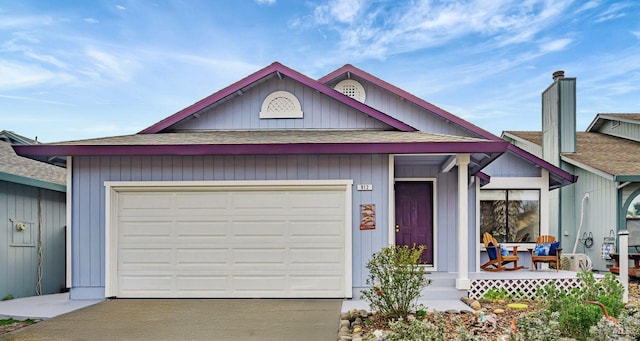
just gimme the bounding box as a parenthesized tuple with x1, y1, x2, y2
(71, 155, 389, 298)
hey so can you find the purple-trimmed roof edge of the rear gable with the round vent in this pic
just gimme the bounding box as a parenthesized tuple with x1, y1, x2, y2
(318, 64, 500, 140)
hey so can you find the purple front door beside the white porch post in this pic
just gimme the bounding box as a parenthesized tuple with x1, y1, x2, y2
(395, 181, 433, 264)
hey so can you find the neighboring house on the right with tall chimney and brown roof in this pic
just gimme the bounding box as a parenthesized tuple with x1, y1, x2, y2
(502, 74, 640, 271)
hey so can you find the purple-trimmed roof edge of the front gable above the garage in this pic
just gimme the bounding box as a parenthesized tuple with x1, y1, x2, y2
(139, 62, 416, 134)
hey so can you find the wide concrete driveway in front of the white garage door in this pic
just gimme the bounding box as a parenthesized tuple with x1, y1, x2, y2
(0, 299, 342, 341)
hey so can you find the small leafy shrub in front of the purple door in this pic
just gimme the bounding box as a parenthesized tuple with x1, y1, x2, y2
(362, 246, 431, 319)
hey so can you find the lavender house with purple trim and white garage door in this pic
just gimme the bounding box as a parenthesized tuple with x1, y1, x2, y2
(15, 63, 575, 298)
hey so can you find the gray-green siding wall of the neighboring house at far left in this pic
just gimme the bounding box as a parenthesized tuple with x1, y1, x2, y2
(0, 181, 66, 299)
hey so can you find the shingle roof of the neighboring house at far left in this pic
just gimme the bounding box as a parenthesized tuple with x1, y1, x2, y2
(0, 141, 67, 186)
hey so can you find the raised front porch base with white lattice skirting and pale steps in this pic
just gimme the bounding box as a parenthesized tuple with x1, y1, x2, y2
(342, 269, 604, 311)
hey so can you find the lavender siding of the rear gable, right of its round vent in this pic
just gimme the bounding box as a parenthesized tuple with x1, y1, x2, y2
(328, 76, 478, 137)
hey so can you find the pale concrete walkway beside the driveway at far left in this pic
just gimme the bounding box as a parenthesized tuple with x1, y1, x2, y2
(0, 293, 103, 320)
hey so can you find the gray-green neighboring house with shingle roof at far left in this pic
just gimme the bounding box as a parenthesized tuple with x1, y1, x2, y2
(0, 131, 66, 299)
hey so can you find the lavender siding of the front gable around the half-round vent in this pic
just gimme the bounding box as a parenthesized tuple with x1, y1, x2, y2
(172, 77, 391, 130)
